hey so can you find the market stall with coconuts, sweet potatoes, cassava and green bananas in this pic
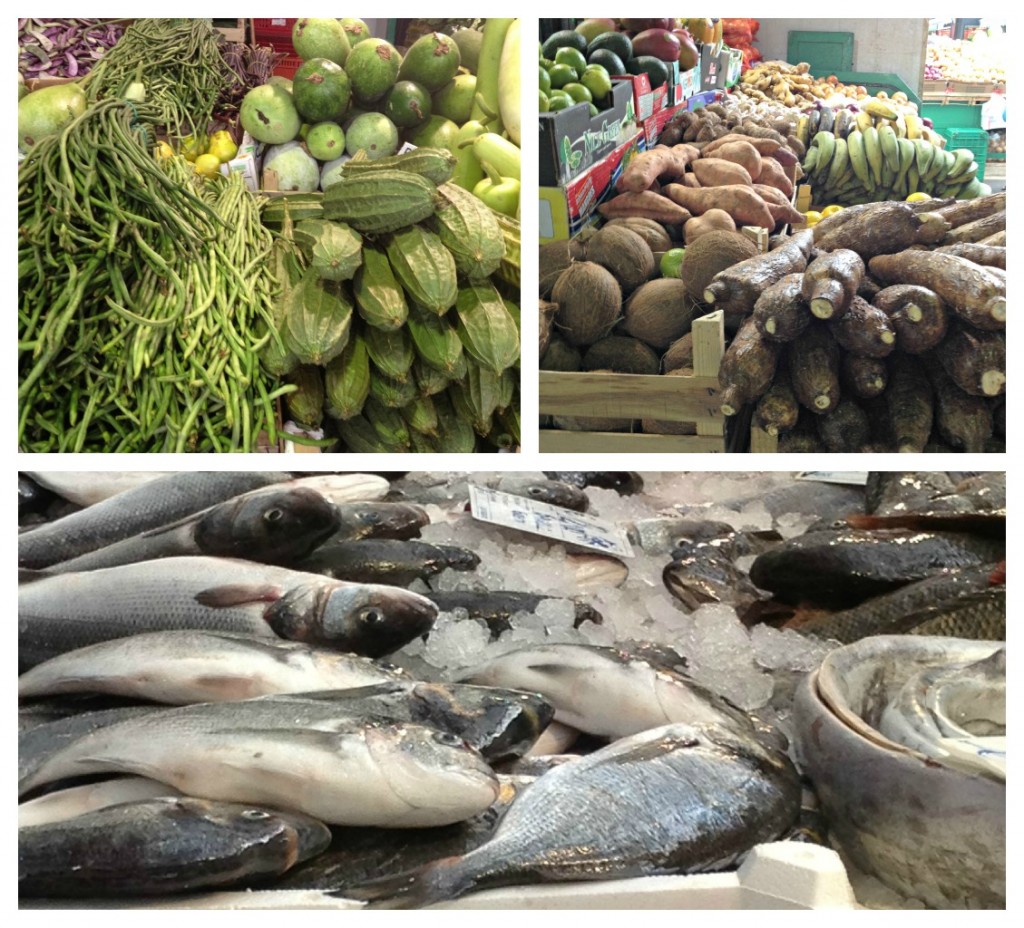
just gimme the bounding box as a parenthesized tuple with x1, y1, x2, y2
(539, 19, 1006, 452)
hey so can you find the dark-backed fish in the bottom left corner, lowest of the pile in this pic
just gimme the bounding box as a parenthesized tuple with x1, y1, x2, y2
(17, 797, 331, 897)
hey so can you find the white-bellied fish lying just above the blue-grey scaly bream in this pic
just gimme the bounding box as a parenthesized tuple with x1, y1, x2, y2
(459, 644, 753, 737)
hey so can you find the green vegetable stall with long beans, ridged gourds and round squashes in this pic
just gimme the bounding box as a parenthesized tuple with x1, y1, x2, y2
(18, 18, 520, 452)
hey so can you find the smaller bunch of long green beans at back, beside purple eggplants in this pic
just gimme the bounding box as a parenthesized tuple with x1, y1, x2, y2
(82, 19, 236, 135)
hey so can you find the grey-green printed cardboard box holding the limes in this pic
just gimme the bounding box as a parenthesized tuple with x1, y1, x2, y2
(539, 81, 636, 187)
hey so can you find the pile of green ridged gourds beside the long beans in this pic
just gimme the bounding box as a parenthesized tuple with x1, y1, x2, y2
(262, 147, 519, 452)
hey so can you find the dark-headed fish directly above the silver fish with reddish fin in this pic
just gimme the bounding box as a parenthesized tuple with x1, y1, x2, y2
(47, 486, 339, 574)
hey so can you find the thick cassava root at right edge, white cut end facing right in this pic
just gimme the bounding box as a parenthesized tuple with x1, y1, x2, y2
(868, 251, 1007, 332)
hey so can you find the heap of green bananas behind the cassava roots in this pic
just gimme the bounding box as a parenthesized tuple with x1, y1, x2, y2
(797, 93, 991, 206)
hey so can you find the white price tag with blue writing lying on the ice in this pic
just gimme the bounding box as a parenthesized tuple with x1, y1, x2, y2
(469, 484, 634, 557)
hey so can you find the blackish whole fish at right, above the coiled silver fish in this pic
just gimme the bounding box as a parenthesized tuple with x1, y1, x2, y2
(750, 529, 1006, 608)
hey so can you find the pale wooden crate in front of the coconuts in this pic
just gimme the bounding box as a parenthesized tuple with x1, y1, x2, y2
(539, 310, 725, 453)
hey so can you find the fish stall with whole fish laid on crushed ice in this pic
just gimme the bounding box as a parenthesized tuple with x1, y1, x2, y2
(17, 471, 1007, 910)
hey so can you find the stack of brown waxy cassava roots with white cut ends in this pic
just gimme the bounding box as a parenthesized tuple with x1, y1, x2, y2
(705, 195, 1007, 452)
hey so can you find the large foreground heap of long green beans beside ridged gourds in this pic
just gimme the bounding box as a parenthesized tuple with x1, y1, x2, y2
(18, 99, 288, 452)
